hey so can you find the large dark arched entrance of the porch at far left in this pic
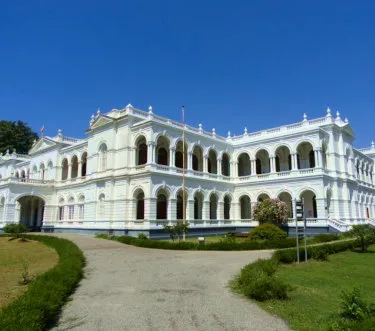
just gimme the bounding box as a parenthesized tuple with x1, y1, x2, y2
(17, 195, 45, 229)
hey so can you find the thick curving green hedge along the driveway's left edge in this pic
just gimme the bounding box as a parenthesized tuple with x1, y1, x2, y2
(0, 235, 85, 331)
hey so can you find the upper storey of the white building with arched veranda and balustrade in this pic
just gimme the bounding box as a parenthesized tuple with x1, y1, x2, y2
(0, 105, 375, 191)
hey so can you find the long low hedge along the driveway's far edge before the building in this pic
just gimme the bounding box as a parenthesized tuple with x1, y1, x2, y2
(96, 234, 302, 251)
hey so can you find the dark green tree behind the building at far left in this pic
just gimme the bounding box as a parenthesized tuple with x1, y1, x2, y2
(0, 121, 38, 154)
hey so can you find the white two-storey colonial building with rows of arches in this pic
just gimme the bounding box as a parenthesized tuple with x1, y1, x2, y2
(0, 105, 375, 237)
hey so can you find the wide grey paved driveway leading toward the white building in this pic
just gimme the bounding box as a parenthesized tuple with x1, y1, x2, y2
(50, 234, 288, 331)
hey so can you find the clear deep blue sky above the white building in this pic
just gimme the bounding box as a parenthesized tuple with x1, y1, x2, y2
(0, 0, 375, 147)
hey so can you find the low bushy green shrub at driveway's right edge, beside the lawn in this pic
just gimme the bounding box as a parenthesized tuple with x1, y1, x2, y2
(234, 260, 288, 301)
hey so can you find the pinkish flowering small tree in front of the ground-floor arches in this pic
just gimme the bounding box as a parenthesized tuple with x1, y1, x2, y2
(253, 199, 289, 226)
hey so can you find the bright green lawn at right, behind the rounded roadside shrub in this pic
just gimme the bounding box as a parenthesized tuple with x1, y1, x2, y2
(260, 245, 375, 331)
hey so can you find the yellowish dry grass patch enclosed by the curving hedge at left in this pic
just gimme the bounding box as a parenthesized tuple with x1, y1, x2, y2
(0, 237, 59, 310)
